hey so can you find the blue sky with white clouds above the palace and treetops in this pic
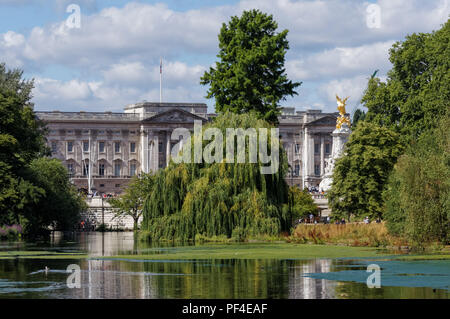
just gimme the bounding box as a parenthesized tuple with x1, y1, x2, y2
(0, 0, 450, 112)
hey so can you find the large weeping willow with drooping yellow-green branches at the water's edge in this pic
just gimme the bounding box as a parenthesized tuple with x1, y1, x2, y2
(142, 113, 292, 240)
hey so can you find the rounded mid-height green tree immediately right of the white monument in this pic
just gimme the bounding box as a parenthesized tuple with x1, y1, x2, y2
(328, 122, 403, 219)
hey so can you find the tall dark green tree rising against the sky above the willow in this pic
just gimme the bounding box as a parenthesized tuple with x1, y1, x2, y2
(200, 10, 301, 123)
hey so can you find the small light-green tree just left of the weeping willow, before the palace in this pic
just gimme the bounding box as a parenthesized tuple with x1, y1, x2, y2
(108, 174, 154, 231)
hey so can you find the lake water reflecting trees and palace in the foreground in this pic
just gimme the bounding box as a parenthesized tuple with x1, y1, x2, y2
(0, 232, 450, 299)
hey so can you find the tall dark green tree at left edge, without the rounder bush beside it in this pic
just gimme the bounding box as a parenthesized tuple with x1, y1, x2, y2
(0, 63, 48, 228)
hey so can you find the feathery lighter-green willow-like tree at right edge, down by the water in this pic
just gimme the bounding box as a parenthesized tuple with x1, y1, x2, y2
(384, 115, 450, 246)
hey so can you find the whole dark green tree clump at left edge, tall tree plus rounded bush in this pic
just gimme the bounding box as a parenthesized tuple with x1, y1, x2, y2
(0, 64, 83, 234)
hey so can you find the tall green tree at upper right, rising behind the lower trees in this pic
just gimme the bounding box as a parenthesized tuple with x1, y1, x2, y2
(362, 20, 450, 143)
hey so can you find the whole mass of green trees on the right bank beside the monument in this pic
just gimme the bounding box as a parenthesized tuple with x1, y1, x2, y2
(329, 20, 450, 248)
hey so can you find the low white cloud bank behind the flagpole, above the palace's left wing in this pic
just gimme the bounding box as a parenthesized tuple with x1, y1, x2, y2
(33, 61, 205, 111)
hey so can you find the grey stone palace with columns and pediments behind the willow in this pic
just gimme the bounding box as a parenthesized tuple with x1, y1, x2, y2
(35, 102, 339, 194)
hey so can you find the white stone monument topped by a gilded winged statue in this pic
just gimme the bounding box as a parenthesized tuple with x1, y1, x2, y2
(319, 95, 352, 192)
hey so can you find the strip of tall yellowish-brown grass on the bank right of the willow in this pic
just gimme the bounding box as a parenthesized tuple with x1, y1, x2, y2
(291, 223, 408, 247)
